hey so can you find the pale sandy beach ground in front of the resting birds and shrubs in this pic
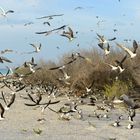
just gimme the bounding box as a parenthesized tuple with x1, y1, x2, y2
(0, 91, 140, 140)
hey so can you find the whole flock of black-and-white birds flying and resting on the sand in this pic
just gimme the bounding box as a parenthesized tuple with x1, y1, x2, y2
(0, 3, 140, 135)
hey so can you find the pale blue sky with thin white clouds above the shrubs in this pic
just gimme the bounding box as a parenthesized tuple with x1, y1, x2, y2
(0, 0, 140, 67)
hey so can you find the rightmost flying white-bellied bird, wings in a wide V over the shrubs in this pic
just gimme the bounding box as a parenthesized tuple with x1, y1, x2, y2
(116, 40, 138, 58)
